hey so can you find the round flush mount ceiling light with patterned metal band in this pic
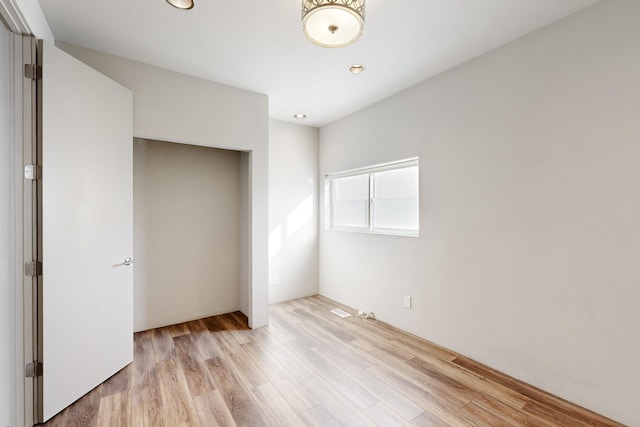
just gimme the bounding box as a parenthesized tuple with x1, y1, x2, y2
(302, 0, 365, 47)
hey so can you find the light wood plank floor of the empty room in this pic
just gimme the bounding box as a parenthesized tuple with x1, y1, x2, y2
(42, 296, 619, 427)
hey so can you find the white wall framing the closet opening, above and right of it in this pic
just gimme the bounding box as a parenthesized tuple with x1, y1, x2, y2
(59, 43, 269, 327)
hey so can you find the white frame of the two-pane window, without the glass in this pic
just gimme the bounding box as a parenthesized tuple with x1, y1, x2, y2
(325, 157, 420, 237)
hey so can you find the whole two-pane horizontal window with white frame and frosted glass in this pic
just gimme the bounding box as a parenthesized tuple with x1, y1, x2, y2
(326, 158, 419, 236)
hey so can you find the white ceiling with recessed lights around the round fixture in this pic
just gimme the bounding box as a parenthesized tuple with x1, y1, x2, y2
(40, 0, 598, 126)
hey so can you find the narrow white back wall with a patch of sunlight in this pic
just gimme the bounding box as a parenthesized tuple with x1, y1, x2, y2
(269, 120, 318, 303)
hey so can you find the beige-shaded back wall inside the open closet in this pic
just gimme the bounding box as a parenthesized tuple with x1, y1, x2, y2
(133, 138, 240, 331)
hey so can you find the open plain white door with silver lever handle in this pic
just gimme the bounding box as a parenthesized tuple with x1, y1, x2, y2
(39, 42, 133, 420)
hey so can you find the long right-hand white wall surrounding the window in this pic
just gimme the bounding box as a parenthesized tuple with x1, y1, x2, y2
(320, 0, 640, 426)
